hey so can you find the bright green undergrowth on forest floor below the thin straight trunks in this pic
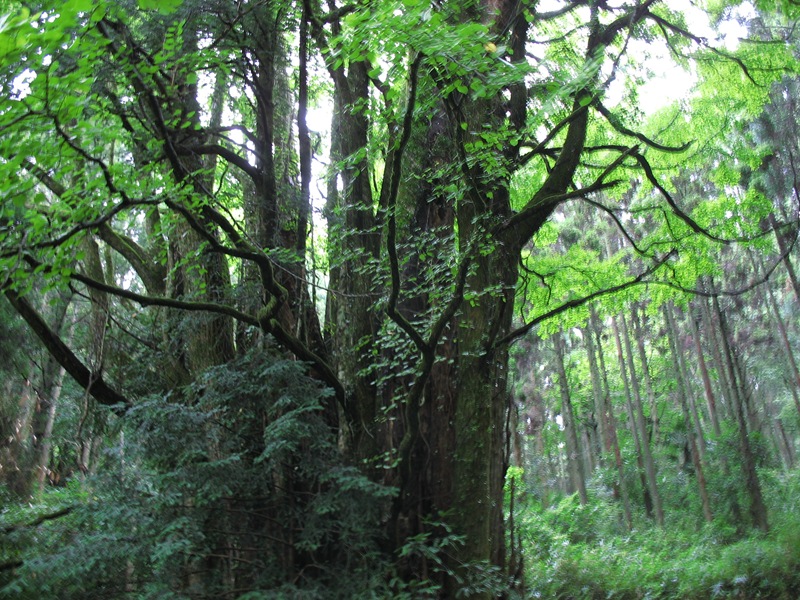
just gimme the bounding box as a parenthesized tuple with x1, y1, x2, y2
(520, 474, 800, 600)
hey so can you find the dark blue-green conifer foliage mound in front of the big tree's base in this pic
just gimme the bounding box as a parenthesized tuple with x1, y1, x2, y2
(2, 355, 400, 598)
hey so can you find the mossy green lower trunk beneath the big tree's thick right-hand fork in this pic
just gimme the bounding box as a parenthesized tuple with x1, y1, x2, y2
(453, 244, 517, 584)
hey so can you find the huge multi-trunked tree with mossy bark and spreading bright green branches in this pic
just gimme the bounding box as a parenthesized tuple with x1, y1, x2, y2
(0, 0, 792, 595)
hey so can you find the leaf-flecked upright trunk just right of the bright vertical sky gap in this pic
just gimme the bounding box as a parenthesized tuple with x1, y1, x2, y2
(325, 62, 380, 464)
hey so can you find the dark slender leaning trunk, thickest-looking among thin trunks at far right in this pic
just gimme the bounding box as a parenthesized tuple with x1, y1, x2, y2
(713, 296, 769, 531)
